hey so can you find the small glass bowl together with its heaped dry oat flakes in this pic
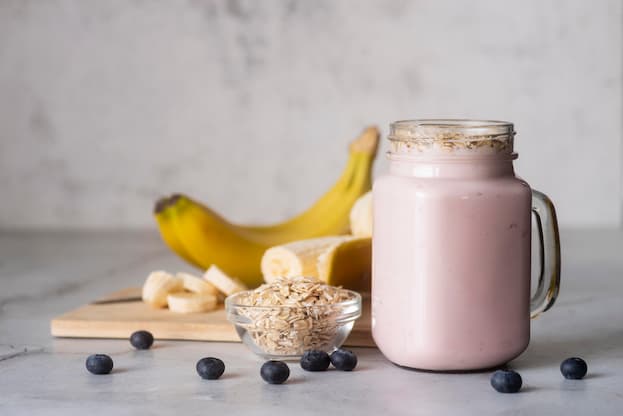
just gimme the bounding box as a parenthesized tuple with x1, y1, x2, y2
(225, 277, 361, 359)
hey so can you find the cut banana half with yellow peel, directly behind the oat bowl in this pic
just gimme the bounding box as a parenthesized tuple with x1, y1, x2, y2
(262, 236, 372, 291)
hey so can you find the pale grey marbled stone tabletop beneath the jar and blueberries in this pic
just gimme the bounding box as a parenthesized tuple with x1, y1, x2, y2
(0, 231, 623, 416)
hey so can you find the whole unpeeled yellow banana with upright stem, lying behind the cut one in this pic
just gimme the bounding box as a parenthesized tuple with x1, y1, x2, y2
(154, 127, 379, 287)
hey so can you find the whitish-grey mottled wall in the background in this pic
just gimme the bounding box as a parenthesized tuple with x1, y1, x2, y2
(0, 0, 623, 227)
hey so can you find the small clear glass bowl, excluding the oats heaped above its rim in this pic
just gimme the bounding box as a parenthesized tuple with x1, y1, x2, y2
(225, 289, 361, 360)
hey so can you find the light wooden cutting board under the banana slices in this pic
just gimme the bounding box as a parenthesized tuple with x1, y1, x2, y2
(50, 288, 375, 347)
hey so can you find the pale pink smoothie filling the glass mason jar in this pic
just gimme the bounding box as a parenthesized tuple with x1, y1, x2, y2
(372, 155, 531, 371)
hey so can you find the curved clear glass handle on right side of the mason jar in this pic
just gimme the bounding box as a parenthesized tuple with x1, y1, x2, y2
(530, 190, 560, 318)
